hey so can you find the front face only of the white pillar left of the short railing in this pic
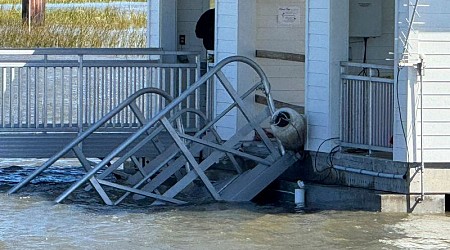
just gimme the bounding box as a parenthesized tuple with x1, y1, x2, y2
(305, 0, 330, 150)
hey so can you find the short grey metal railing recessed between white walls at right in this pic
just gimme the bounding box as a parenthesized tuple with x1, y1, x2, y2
(340, 62, 394, 153)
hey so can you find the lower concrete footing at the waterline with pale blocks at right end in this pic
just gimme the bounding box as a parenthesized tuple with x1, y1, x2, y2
(269, 181, 445, 214)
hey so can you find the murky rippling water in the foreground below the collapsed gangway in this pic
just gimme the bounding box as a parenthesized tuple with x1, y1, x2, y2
(0, 159, 450, 249)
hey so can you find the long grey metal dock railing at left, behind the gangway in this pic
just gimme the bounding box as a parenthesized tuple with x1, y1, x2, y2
(0, 48, 202, 133)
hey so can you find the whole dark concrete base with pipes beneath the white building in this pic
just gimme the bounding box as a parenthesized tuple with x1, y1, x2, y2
(268, 152, 450, 213)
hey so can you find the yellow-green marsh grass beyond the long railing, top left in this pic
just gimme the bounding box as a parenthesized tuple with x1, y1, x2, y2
(0, 8, 146, 48)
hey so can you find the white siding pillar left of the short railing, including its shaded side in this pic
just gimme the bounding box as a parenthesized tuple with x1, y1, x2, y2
(306, 0, 349, 152)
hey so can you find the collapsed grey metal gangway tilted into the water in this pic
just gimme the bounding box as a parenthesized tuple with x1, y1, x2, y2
(8, 56, 298, 205)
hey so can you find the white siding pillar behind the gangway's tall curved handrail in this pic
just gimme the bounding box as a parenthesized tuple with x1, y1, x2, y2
(215, 0, 256, 139)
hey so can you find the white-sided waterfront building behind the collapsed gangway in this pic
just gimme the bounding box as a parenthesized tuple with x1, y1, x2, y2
(150, 0, 450, 212)
